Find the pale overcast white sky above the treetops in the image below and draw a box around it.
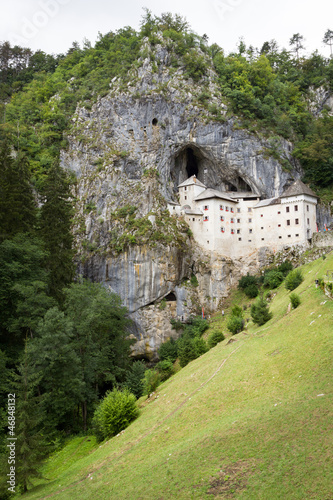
[0,0,333,56]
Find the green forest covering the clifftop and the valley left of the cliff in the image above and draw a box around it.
[0,11,333,489]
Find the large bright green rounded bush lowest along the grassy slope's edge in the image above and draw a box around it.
[93,389,139,441]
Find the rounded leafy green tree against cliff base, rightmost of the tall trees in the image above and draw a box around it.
[64,280,133,430]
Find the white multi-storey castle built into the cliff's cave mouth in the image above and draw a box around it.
[168,175,317,258]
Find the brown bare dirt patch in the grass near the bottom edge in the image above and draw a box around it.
[207,460,256,498]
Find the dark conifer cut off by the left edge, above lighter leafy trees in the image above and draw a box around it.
[0,140,36,240]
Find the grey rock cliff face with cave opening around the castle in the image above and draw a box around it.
[62,41,300,359]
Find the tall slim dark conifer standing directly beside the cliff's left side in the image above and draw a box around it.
[40,163,74,301]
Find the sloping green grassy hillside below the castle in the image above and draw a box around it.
[23,254,333,500]
